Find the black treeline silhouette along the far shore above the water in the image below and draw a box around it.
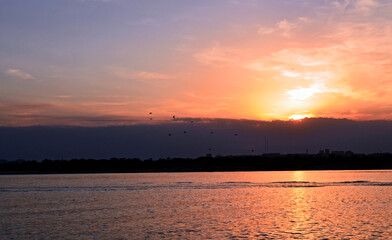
[0,153,392,174]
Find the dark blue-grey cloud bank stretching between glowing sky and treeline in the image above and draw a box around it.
[0,118,392,160]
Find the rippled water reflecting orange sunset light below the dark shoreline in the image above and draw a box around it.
[0,171,392,239]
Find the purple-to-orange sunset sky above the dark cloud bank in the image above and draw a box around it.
[0,0,392,126]
